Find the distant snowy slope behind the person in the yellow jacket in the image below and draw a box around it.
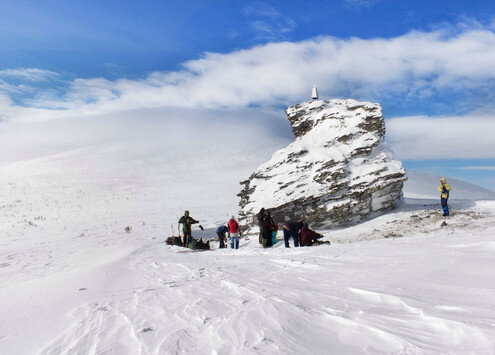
[403,170,495,200]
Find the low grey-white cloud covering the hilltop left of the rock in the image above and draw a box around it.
[0,108,290,167]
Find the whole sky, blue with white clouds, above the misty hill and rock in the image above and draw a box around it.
[0,0,495,189]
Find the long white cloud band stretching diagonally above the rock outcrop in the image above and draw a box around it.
[3,25,495,119]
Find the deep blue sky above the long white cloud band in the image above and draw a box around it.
[0,0,495,78]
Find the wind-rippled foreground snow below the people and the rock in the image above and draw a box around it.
[37,227,495,354]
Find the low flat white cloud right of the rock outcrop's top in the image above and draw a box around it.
[386,114,495,160]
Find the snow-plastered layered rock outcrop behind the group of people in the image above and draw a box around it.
[238,100,406,228]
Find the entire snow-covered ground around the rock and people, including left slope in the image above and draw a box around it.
[0,143,495,354]
